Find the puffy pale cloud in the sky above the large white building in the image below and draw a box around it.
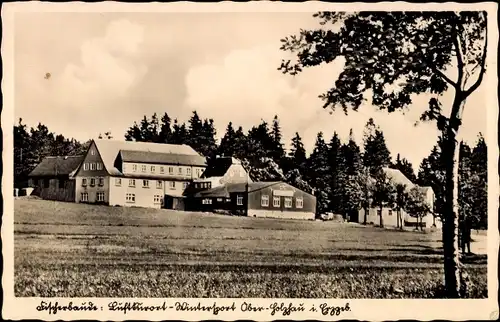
[58,20,147,108]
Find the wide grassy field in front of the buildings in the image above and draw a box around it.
[14,199,487,298]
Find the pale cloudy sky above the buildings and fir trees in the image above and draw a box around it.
[14,12,486,170]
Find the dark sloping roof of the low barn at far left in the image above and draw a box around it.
[29,155,84,177]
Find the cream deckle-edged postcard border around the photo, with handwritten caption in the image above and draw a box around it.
[2,1,499,321]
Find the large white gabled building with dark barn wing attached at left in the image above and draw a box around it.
[31,140,206,209]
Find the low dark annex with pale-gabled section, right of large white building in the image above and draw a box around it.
[185,156,316,220]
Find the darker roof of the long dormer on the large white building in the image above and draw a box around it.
[120,150,206,167]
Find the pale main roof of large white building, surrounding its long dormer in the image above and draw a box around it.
[94,140,206,175]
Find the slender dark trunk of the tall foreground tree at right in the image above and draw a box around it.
[442,117,464,298]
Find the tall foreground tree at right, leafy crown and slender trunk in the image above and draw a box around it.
[279,11,487,298]
